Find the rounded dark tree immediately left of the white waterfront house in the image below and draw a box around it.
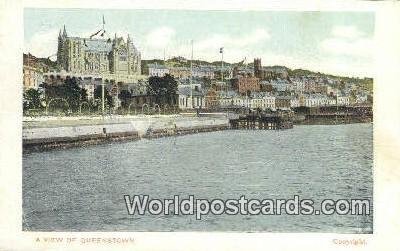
[148,74,178,105]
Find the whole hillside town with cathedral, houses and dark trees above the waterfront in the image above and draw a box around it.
[23,26,373,114]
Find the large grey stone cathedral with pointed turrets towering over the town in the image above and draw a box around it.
[57,26,141,77]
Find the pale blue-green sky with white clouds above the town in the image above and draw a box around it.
[24,8,375,77]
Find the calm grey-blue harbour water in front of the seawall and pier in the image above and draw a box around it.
[23,124,373,233]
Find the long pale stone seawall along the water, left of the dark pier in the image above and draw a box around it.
[22,117,229,152]
